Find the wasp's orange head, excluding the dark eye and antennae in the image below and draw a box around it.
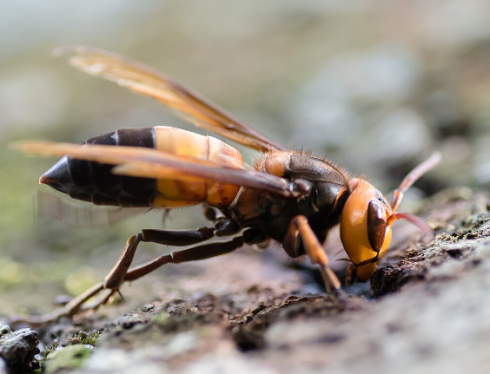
[340,179,391,280]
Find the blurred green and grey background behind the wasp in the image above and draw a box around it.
[0,0,490,314]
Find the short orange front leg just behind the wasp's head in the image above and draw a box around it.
[283,215,342,296]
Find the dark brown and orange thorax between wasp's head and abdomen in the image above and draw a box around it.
[227,152,349,242]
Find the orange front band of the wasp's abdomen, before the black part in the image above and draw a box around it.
[151,126,243,208]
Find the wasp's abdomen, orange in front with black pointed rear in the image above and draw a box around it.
[40,127,243,208]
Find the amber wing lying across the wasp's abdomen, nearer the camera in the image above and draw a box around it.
[13,142,299,197]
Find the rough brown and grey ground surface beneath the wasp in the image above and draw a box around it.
[0,189,490,373]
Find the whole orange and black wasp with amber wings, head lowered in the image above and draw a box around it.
[17,46,440,320]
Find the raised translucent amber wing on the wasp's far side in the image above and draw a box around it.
[55,46,284,152]
